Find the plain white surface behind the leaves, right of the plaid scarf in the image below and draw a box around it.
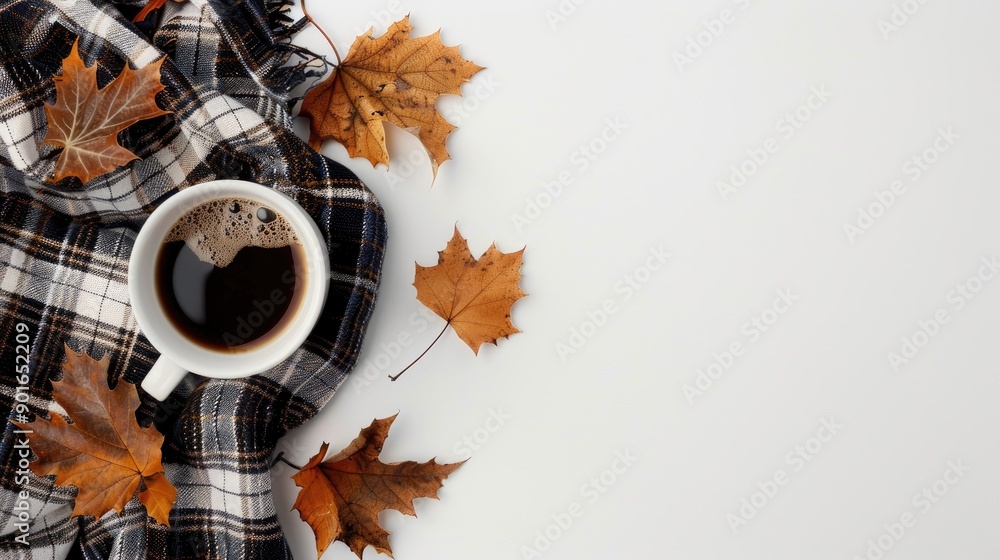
[274,0,1000,560]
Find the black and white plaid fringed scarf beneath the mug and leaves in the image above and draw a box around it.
[0,0,386,560]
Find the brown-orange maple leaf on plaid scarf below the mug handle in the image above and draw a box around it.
[17,346,177,526]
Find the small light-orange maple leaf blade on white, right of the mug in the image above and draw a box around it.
[413,227,527,354]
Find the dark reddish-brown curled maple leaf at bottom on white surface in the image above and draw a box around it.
[292,416,462,558]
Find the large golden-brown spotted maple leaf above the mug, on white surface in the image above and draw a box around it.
[301,16,482,176]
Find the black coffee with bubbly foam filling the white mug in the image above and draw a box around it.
[156,199,305,351]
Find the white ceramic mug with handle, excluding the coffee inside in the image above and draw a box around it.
[128,180,330,401]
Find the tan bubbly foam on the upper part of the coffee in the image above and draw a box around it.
[165,198,302,268]
